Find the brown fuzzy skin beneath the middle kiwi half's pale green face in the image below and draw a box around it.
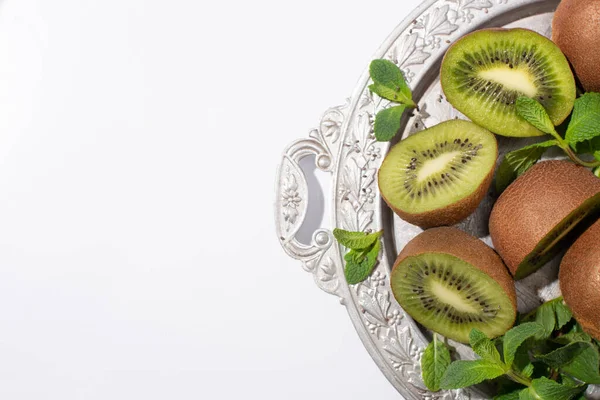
[378,142,498,229]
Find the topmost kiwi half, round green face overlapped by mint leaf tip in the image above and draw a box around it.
[441,29,575,137]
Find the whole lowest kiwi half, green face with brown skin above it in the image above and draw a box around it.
[390,227,517,343]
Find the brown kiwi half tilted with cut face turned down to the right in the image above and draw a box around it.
[489,160,600,279]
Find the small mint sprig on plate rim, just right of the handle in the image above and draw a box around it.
[333,228,383,285]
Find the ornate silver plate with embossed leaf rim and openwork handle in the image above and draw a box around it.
[275,0,595,400]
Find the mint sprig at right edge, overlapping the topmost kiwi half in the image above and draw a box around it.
[496,93,600,192]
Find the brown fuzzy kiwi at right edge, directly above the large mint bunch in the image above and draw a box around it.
[558,221,600,340]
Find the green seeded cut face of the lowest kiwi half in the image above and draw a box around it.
[392,253,515,343]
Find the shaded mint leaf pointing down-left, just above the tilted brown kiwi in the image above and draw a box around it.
[496,140,558,193]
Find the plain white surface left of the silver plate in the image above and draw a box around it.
[0,0,418,400]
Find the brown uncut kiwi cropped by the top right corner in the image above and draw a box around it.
[552,0,600,92]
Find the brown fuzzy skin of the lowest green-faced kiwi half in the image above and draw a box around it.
[392,227,517,318]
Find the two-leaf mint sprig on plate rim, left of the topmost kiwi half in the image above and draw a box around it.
[369,59,417,142]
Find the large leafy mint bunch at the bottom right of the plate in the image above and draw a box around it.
[421,298,600,400]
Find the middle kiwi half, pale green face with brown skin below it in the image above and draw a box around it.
[378,120,498,228]
